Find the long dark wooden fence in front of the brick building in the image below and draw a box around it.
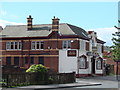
[1,73,75,87]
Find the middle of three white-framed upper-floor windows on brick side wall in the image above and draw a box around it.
[31,41,44,50]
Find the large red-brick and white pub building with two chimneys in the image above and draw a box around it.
[0,16,105,77]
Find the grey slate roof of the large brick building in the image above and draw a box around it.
[1,23,89,39]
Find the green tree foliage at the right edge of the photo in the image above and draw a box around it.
[111,27,120,60]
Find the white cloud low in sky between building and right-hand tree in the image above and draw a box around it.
[87,27,117,46]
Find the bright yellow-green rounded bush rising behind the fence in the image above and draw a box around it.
[26,64,48,73]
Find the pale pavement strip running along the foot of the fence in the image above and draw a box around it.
[12,81,101,90]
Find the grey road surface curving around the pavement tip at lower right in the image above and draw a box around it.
[48,76,120,90]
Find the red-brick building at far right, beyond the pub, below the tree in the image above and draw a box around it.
[103,46,120,74]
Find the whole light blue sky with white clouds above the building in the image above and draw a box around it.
[0,2,118,46]
